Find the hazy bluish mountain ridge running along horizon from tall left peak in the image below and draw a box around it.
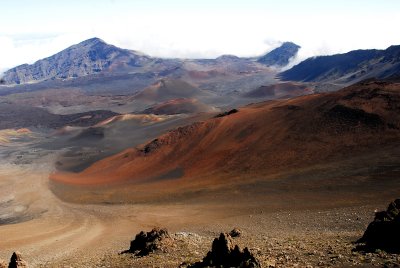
[2,37,300,85]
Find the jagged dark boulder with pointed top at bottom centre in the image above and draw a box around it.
[189,233,261,268]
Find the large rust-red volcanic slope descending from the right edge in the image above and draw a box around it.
[51,81,400,187]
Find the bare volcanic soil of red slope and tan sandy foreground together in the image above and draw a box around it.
[0,81,400,267]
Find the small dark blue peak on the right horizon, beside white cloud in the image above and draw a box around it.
[257,42,300,67]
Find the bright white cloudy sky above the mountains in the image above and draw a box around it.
[0,0,400,73]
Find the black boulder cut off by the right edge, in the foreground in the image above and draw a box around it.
[357,199,400,253]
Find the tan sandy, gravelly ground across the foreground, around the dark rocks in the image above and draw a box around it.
[0,146,400,267]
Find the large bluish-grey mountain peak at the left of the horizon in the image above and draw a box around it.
[3,37,151,84]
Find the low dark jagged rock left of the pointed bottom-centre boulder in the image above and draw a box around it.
[127,228,170,256]
